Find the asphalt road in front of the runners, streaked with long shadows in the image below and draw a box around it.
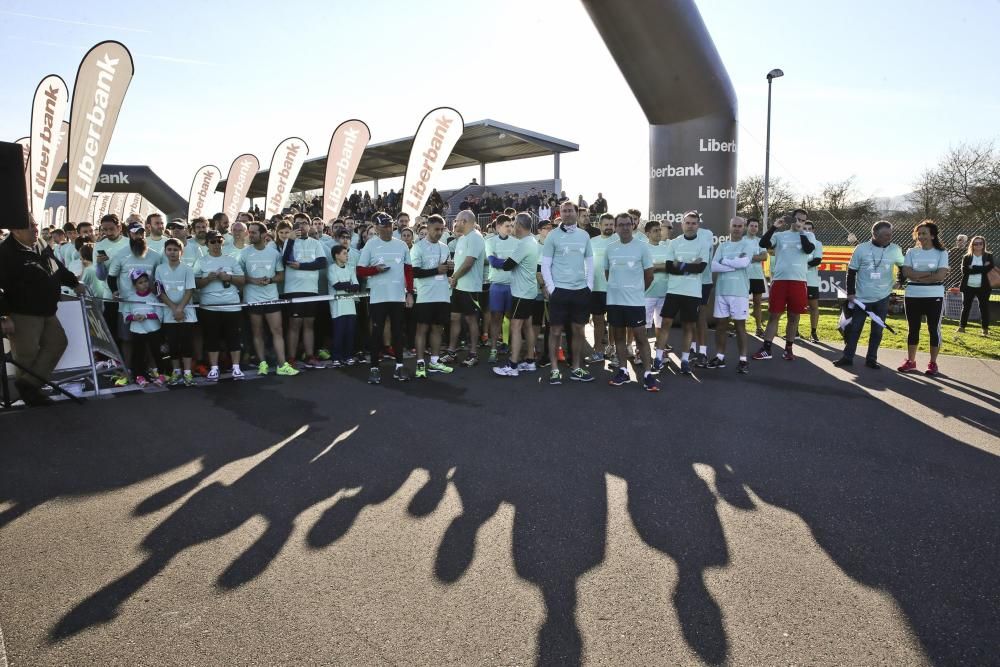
[0,346,1000,666]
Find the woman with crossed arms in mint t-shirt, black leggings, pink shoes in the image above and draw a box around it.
[897,220,948,375]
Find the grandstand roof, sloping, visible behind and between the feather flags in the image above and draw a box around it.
[217,118,580,198]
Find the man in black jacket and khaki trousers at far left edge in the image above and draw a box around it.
[0,221,87,405]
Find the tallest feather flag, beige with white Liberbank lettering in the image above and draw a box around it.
[68,41,135,221]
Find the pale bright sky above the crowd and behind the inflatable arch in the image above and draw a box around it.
[0,0,1000,210]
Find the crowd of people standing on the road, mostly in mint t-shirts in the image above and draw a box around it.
[0,195,994,402]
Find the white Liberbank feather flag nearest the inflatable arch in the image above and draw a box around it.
[401,107,465,219]
